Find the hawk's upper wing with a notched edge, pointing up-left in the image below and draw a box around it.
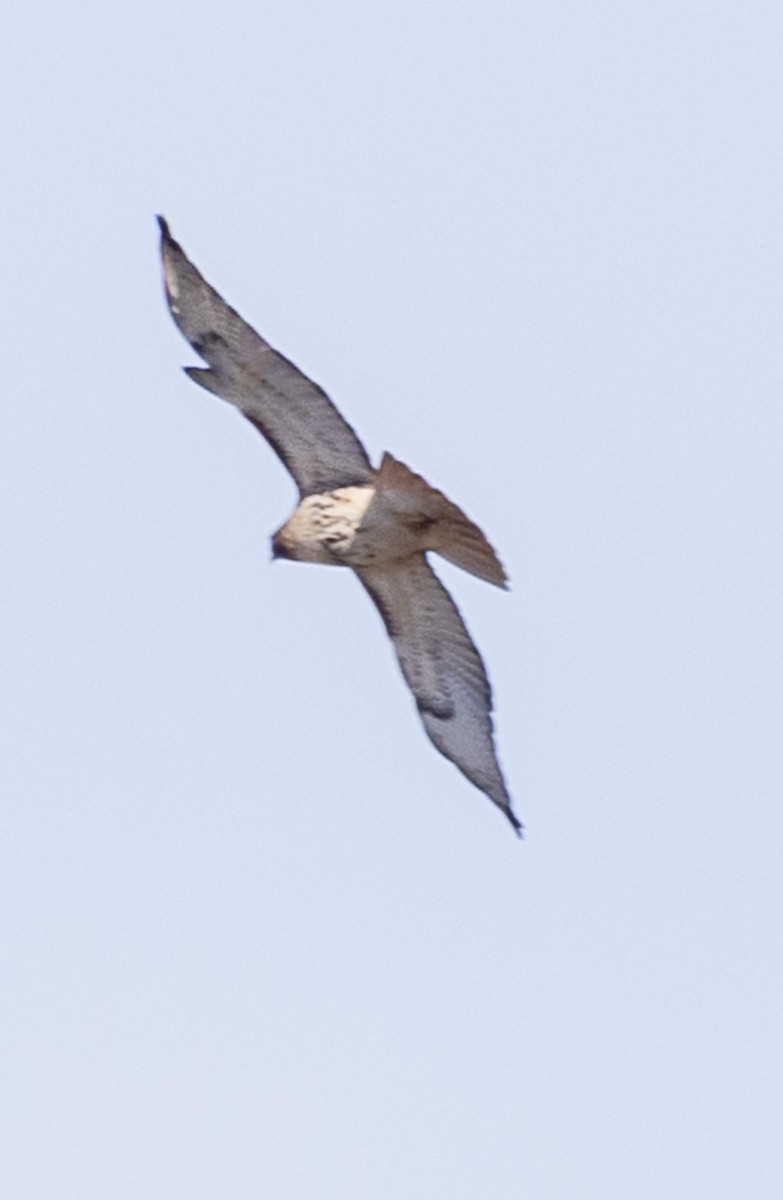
[159,217,372,496]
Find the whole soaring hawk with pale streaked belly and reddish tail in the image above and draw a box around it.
[159,217,522,835]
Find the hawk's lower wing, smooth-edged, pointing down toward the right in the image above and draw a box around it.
[355,554,522,833]
